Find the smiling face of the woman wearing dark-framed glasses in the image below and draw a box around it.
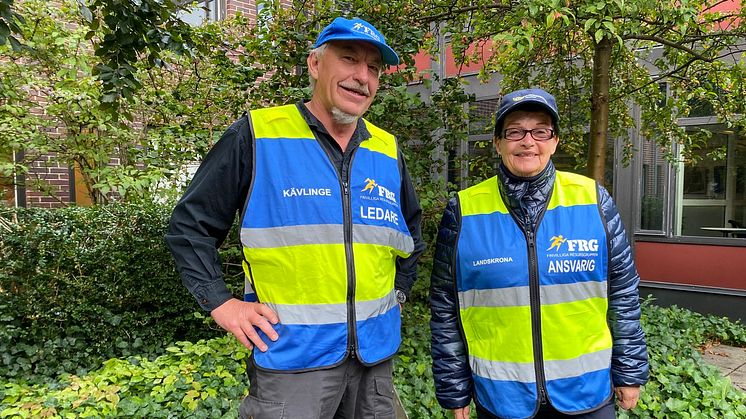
[494,110,559,177]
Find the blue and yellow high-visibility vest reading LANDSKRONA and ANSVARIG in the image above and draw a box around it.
[456,171,612,419]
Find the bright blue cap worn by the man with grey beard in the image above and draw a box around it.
[313,17,399,65]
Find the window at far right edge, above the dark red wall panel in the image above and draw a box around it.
[675,125,746,237]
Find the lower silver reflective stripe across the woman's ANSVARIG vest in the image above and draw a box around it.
[469,349,611,383]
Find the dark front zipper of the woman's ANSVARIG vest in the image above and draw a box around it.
[526,230,548,404]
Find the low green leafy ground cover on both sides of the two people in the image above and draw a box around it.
[0,301,746,419]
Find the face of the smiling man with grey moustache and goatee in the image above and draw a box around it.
[308,41,383,122]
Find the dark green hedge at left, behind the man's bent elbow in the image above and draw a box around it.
[0,204,238,381]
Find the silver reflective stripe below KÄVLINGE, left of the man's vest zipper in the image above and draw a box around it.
[241,224,344,248]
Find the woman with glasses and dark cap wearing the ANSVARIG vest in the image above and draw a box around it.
[430,89,648,419]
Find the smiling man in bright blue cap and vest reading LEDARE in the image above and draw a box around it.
[166,18,424,419]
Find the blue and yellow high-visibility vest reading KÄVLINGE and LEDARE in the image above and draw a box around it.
[240,105,414,371]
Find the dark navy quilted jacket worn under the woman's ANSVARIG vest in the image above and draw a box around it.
[430,162,648,409]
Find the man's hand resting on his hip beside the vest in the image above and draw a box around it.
[210,298,279,352]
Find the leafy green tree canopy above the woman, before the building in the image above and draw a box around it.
[424,0,746,176]
